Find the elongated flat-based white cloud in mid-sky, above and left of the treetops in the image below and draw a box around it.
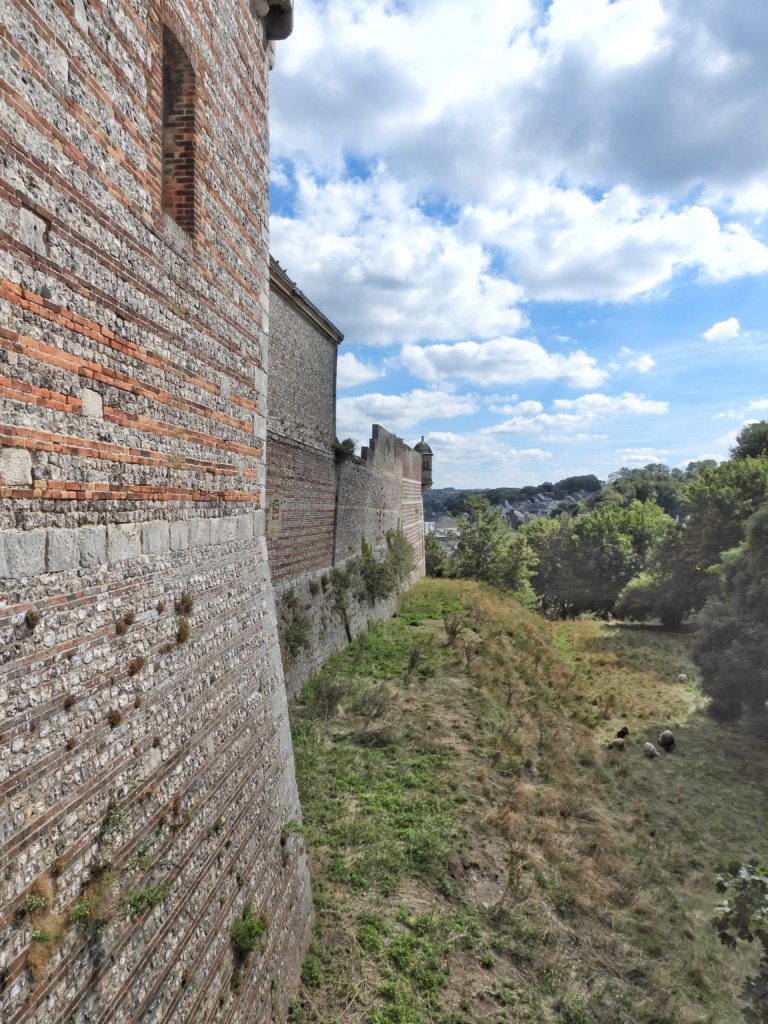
[401,337,608,387]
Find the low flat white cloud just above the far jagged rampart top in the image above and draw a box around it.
[336,388,478,439]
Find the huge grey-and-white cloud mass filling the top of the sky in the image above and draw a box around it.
[271,0,768,201]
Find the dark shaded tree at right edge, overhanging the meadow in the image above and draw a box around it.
[694,503,768,719]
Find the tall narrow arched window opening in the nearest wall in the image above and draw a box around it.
[163,27,195,236]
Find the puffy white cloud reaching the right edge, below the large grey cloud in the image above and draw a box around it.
[464,182,768,301]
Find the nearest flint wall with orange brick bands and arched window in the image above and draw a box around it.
[0,0,311,1024]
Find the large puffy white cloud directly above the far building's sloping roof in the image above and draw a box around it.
[271,166,525,345]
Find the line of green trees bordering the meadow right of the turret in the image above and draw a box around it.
[427,421,768,719]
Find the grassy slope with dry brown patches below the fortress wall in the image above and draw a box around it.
[291,581,768,1024]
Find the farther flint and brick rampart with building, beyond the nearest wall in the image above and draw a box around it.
[266,274,424,695]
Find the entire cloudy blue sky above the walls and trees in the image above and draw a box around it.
[271,0,768,486]
